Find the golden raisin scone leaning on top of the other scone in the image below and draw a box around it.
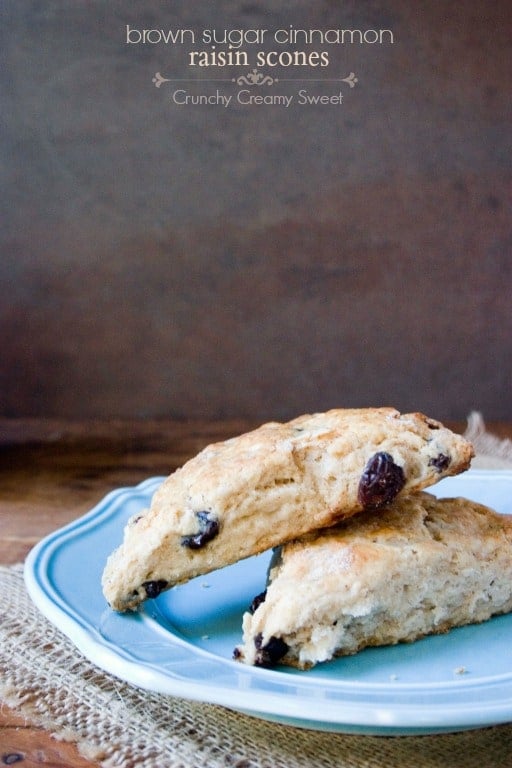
[103,408,472,611]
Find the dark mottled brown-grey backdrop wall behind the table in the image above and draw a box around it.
[0,0,512,419]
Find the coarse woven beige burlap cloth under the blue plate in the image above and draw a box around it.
[0,414,512,768]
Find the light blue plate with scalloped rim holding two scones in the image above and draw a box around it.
[25,470,512,736]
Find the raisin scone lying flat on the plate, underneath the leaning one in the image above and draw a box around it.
[235,492,512,669]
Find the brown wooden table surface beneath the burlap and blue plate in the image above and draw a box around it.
[0,420,512,768]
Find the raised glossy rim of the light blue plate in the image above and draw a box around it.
[24,468,512,735]
